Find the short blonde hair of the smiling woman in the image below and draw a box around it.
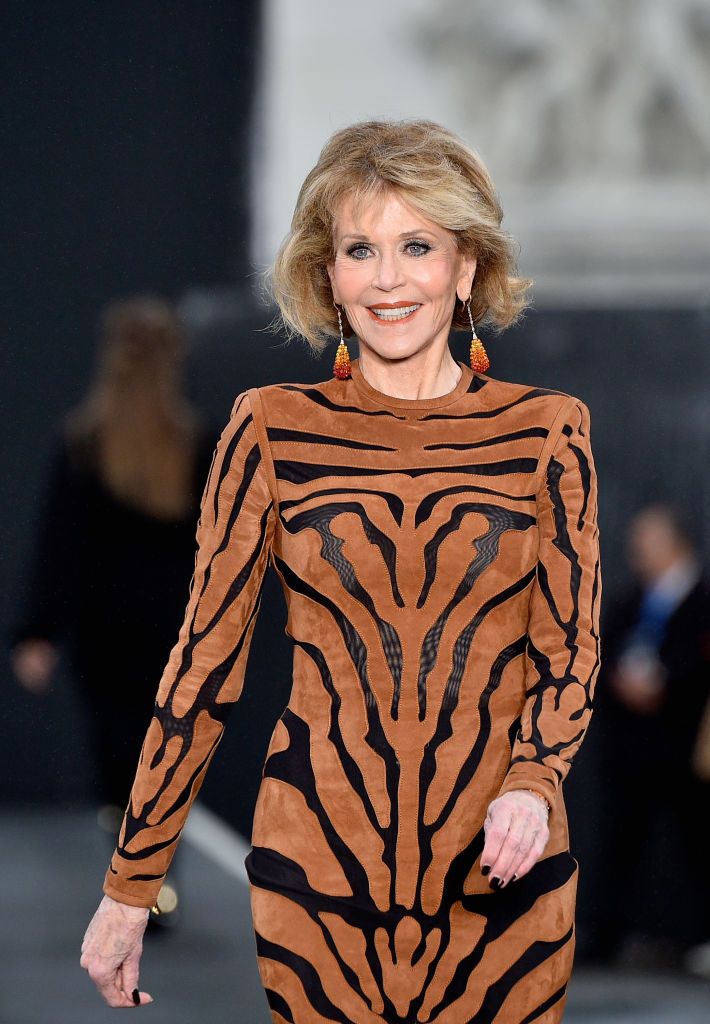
[262,120,533,354]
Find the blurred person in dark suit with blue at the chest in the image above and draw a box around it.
[592,502,710,970]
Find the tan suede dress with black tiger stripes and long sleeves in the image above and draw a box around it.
[103,359,601,1024]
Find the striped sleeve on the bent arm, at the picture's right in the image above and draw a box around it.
[498,397,601,804]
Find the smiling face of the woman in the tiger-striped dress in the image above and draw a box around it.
[327,193,476,359]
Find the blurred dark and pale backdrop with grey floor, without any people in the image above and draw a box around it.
[0,0,710,1024]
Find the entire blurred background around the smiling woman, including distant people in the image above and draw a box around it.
[0,0,710,1024]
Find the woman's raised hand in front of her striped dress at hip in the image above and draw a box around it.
[481,790,550,889]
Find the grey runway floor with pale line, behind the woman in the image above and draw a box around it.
[0,803,710,1024]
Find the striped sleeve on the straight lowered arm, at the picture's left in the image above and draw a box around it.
[103,391,276,907]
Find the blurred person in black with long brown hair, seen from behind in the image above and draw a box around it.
[10,295,215,926]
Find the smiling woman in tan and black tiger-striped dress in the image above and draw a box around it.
[81,121,601,1024]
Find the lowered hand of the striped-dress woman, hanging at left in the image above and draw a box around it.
[79,896,153,1007]
